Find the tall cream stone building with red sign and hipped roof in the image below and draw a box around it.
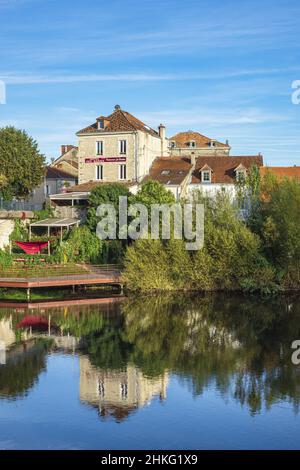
[77,106,168,184]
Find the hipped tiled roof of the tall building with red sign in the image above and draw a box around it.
[77,107,159,137]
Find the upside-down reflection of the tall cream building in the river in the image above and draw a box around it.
[79,356,168,422]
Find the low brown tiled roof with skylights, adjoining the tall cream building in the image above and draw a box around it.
[143,157,192,185]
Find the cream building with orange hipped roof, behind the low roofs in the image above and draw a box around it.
[169,131,230,157]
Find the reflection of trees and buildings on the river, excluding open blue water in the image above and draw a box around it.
[0,295,300,421]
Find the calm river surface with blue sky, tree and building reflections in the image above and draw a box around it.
[0,294,300,449]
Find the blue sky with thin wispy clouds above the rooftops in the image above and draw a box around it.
[0,0,300,166]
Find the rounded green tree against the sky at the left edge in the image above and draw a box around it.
[0,127,45,200]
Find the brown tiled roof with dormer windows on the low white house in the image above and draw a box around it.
[191,155,263,184]
